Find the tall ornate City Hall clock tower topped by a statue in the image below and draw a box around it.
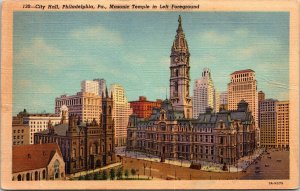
[170,15,192,118]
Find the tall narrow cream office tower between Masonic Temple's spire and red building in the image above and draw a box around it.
[110,84,132,146]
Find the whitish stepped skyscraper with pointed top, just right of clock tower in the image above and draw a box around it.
[193,68,219,118]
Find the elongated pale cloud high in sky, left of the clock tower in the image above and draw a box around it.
[70,26,123,46]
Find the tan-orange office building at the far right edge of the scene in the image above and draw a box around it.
[276,101,289,148]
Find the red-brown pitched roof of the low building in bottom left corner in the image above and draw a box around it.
[12,143,62,173]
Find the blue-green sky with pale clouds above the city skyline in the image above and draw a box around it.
[13,12,289,115]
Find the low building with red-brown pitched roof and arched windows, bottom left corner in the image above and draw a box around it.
[12,143,65,181]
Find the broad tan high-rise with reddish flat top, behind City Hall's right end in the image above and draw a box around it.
[228,69,258,126]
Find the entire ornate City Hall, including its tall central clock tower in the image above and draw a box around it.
[127,16,258,164]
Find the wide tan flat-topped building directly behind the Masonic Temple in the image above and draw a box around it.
[55,92,102,123]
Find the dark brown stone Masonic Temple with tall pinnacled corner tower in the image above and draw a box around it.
[34,92,116,174]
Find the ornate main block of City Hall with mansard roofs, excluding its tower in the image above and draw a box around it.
[127,100,256,164]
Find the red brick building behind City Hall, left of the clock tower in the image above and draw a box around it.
[129,96,162,118]
